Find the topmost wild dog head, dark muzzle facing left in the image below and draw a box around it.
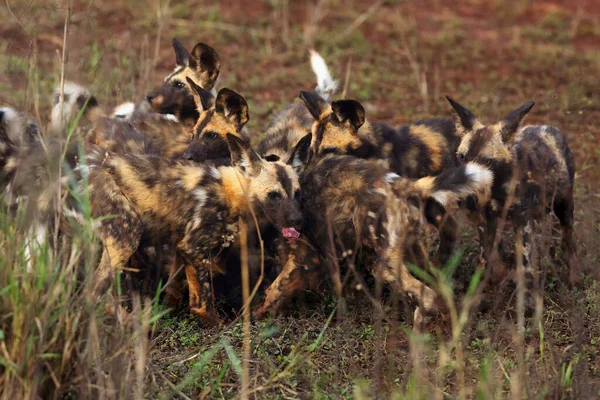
[146,39,221,119]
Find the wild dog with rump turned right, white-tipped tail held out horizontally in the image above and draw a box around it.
[255,134,493,323]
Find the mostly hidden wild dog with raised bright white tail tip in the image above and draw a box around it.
[258,50,337,161]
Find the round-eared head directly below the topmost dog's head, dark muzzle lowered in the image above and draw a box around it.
[183,82,250,162]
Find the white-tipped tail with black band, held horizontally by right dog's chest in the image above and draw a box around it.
[413,162,494,207]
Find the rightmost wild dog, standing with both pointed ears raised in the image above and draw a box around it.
[447,97,579,306]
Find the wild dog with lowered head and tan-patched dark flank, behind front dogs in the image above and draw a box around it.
[300,92,460,263]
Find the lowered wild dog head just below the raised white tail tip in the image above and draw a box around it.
[300,91,368,157]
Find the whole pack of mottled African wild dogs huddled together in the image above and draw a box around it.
[0,39,579,329]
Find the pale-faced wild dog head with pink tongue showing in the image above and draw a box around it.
[226,133,310,241]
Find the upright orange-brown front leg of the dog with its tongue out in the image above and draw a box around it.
[185,264,220,326]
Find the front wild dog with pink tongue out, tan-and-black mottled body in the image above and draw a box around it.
[89,108,302,323]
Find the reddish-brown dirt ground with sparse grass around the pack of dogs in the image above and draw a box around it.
[0,0,600,399]
